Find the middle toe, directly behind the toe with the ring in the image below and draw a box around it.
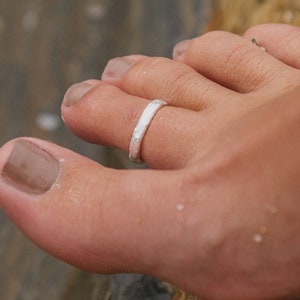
[102,55,234,111]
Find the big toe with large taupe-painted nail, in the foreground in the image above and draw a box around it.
[0,138,189,273]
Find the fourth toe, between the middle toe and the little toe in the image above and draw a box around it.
[174,31,299,93]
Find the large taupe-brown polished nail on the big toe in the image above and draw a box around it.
[1,140,60,195]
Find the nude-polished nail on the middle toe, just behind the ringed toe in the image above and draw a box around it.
[102,57,134,80]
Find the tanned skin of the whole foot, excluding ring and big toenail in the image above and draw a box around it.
[0,24,300,300]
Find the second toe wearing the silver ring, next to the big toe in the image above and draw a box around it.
[62,81,205,169]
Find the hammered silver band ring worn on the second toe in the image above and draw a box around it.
[129,99,168,164]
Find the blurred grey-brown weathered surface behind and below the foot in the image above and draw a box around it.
[0,0,210,300]
